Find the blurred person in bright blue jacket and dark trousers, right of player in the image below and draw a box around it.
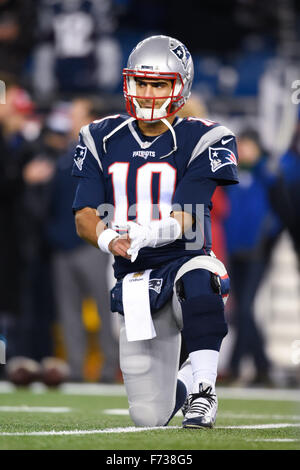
[225,130,280,385]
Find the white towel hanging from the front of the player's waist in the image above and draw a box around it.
[122,269,156,341]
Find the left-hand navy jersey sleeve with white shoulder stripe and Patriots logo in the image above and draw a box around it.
[72,126,105,212]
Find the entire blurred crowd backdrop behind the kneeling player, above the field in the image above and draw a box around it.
[0,0,300,386]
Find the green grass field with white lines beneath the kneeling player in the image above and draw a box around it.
[0,382,300,450]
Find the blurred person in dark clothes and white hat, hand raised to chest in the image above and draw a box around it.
[16,103,69,362]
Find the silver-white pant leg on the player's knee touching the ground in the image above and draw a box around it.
[120,302,181,426]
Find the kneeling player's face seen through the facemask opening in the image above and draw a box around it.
[136,78,173,108]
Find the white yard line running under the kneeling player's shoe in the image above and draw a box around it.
[0,423,300,436]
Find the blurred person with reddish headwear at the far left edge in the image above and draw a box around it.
[0,77,33,364]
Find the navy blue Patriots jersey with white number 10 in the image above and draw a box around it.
[73,115,238,278]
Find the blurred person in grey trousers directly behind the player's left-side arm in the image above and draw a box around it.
[47,98,118,383]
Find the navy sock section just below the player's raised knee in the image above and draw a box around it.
[181,294,228,353]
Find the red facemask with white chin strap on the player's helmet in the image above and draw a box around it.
[123,69,185,122]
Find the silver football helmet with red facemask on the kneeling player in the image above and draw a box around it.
[123,36,194,121]
